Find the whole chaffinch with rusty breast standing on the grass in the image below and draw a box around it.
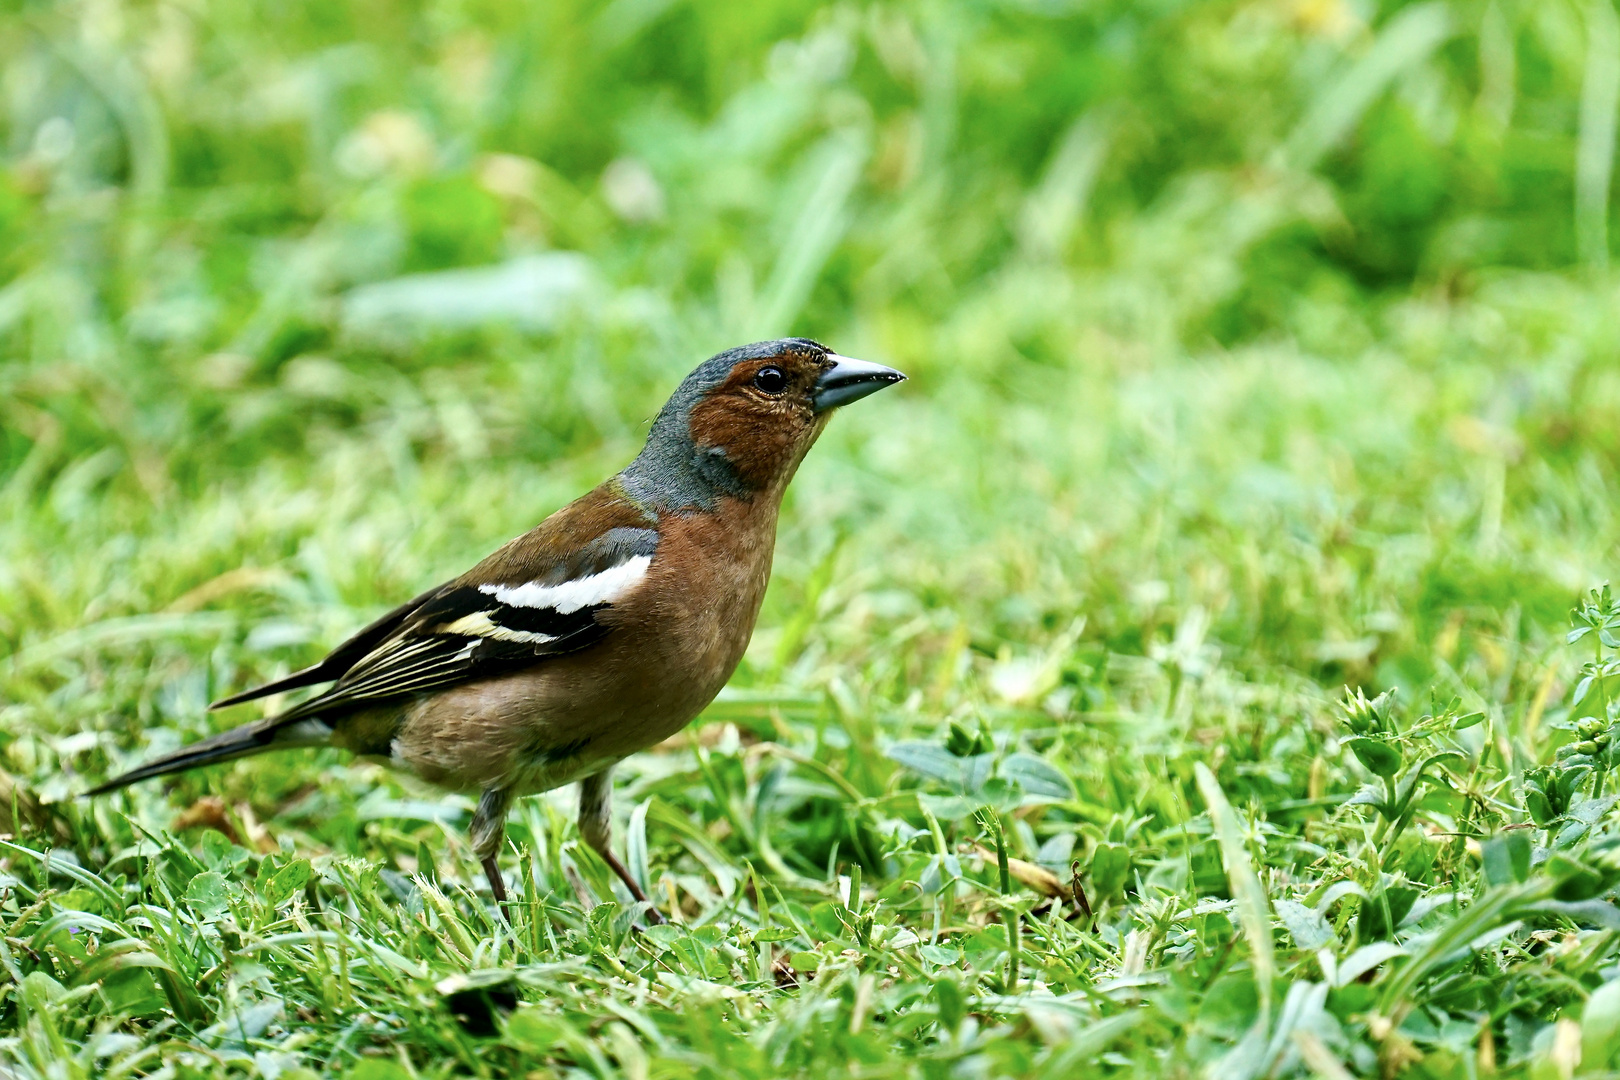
[84,338,906,921]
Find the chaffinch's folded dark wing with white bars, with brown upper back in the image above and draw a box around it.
[222,489,658,727]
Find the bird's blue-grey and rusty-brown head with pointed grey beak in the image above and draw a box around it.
[620,337,906,510]
